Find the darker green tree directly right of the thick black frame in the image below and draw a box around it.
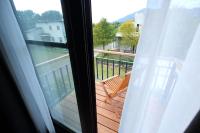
[93,18,115,49]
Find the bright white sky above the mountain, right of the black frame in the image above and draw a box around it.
[91,0,146,23]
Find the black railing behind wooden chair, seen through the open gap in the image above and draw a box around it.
[95,57,133,80]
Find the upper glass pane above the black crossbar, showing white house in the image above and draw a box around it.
[14,0,67,43]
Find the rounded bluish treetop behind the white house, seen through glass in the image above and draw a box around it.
[40,10,62,22]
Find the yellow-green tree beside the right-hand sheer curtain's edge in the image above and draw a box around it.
[118,20,139,52]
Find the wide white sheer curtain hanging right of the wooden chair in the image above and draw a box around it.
[119,0,200,133]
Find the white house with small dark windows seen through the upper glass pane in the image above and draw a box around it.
[25,21,66,43]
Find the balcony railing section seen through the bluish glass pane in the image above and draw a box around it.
[39,65,74,107]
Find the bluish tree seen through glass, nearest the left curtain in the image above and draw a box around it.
[17,10,40,31]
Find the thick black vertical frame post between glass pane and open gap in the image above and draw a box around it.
[61,0,97,133]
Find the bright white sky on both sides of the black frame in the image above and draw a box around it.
[14,0,147,23]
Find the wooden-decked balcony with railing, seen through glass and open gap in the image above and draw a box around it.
[29,42,134,133]
